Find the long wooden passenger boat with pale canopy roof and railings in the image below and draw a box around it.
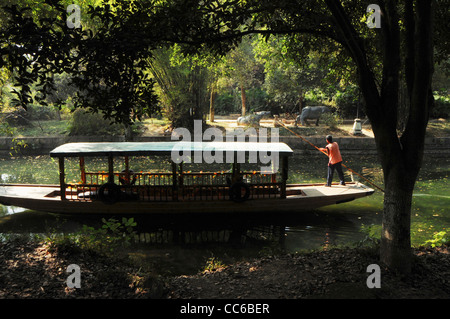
[0,141,374,214]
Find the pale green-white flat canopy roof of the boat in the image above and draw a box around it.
[50,141,293,157]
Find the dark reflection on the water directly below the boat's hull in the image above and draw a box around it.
[0,209,379,252]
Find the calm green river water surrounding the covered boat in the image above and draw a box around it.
[0,154,450,258]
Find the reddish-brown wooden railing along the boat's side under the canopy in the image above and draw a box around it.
[66,171,282,201]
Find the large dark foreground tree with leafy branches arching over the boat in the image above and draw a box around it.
[0,0,449,273]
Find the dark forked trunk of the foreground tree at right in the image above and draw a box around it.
[325,0,434,274]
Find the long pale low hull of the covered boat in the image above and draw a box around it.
[0,183,374,214]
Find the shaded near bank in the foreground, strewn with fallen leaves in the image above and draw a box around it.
[0,241,450,299]
